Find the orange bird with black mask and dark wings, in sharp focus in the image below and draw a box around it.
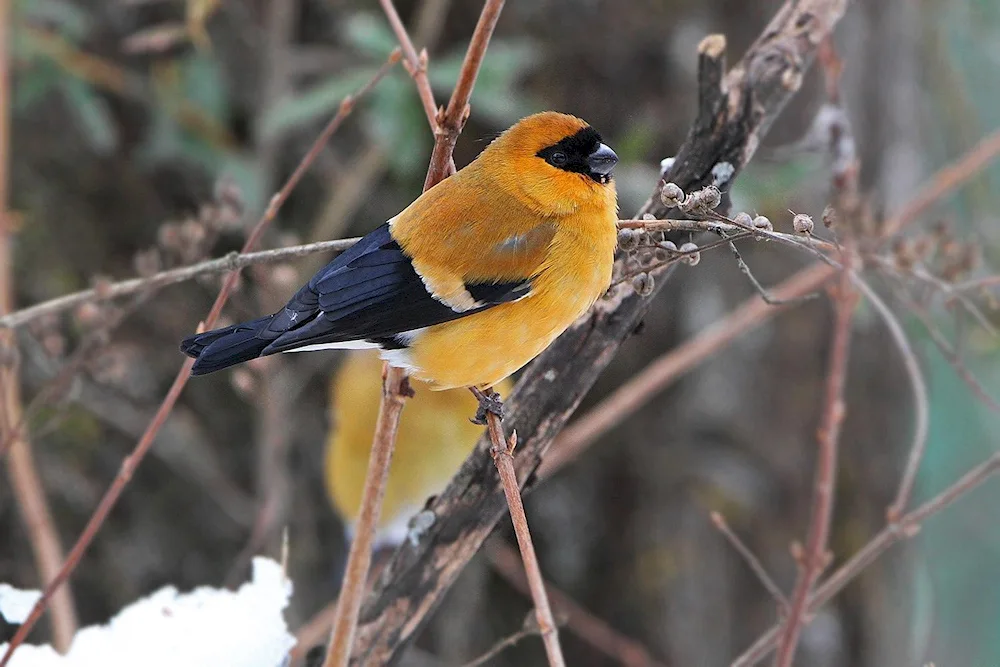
[181,112,618,389]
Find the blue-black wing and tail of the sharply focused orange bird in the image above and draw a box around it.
[181,223,531,375]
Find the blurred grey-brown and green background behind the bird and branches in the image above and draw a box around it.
[0,0,1000,667]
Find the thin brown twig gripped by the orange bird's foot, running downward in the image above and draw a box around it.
[486,412,566,667]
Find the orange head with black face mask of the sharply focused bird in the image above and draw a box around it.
[482,111,618,214]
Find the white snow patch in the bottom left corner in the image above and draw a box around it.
[0,558,295,667]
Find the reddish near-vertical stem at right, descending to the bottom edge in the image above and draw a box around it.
[775,257,858,667]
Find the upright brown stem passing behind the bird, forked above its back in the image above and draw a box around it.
[324,5,503,667]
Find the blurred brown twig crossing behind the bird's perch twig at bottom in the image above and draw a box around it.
[486,541,665,667]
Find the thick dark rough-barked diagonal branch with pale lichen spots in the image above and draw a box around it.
[354,0,847,665]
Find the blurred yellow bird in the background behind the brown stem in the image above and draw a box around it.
[324,350,510,548]
